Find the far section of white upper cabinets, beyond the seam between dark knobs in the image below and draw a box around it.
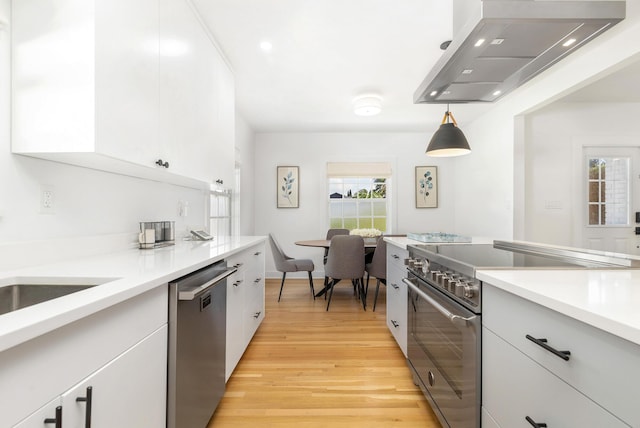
[160,0,234,187]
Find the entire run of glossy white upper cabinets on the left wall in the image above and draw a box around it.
[12,0,234,188]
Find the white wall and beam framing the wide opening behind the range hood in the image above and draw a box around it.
[454,0,640,239]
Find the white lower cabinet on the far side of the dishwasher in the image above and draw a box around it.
[225,243,265,380]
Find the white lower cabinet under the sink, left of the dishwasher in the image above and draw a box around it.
[0,286,168,428]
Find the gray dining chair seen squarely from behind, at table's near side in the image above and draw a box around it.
[324,235,367,311]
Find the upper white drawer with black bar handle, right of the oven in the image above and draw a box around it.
[482,284,640,426]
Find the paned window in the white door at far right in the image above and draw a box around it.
[587,157,630,226]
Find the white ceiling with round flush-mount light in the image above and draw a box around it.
[192,0,640,133]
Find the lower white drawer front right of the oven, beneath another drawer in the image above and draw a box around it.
[482,328,627,428]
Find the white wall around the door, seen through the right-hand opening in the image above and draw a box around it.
[524,103,640,245]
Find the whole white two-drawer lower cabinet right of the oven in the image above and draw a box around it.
[482,283,640,428]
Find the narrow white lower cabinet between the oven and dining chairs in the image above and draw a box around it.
[387,243,409,357]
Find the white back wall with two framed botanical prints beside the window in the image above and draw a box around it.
[254,133,456,276]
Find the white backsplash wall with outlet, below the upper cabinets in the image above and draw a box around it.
[0,0,205,270]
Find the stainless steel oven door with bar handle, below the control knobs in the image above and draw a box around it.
[403,273,482,428]
